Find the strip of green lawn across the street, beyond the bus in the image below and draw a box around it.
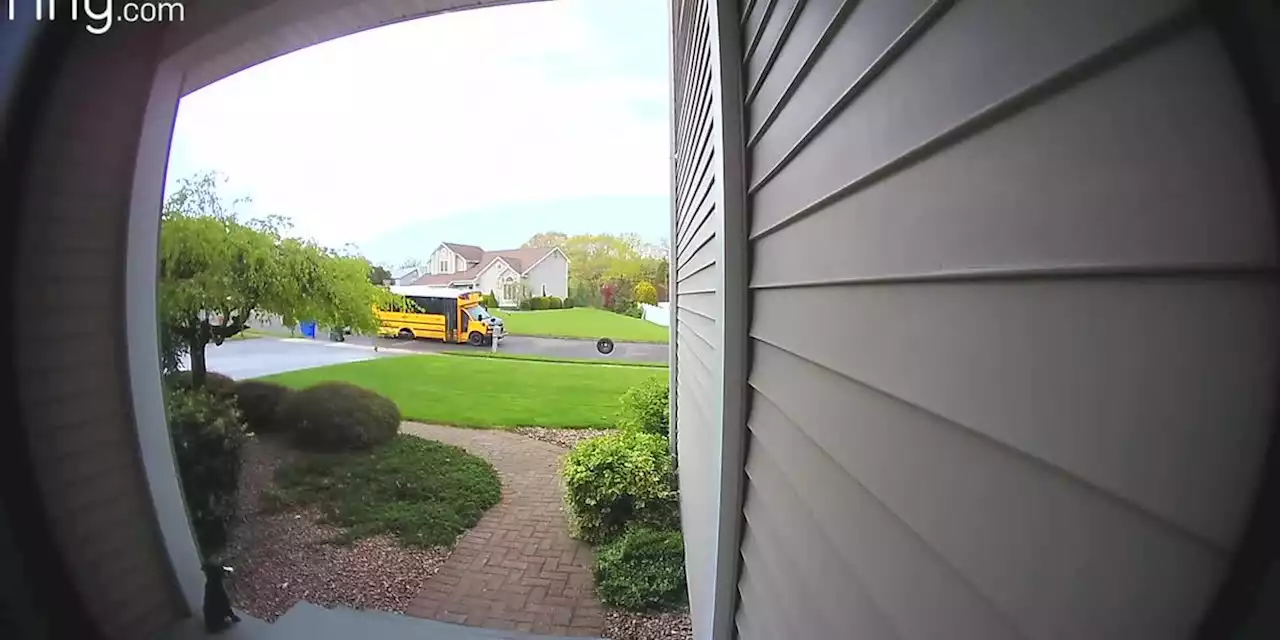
[494,308,669,343]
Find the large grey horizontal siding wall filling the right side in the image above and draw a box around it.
[736,0,1280,640]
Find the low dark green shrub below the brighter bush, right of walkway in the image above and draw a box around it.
[595,527,689,611]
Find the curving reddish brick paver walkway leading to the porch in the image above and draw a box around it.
[401,422,604,637]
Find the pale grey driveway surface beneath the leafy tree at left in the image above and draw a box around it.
[192,338,396,380]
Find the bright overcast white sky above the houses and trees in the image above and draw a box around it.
[169,0,669,262]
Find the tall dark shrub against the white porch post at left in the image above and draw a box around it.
[165,388,244,558]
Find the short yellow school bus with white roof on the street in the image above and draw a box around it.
[378,285,507,347]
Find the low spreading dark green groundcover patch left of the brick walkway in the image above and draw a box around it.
[268,435,502,547]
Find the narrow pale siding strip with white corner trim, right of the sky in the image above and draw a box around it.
[671,0,737,639]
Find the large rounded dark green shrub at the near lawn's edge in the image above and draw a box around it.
[278,381,401,452]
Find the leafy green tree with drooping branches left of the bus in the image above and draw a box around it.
[159,173,404,388]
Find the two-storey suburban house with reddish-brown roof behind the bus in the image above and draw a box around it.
[412,242,568,307]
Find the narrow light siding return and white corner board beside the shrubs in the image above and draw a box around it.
[669,0,749,640]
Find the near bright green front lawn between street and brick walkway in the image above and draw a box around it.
[265,356,667,428]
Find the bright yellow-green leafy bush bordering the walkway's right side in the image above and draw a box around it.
[562,431,680,543]
